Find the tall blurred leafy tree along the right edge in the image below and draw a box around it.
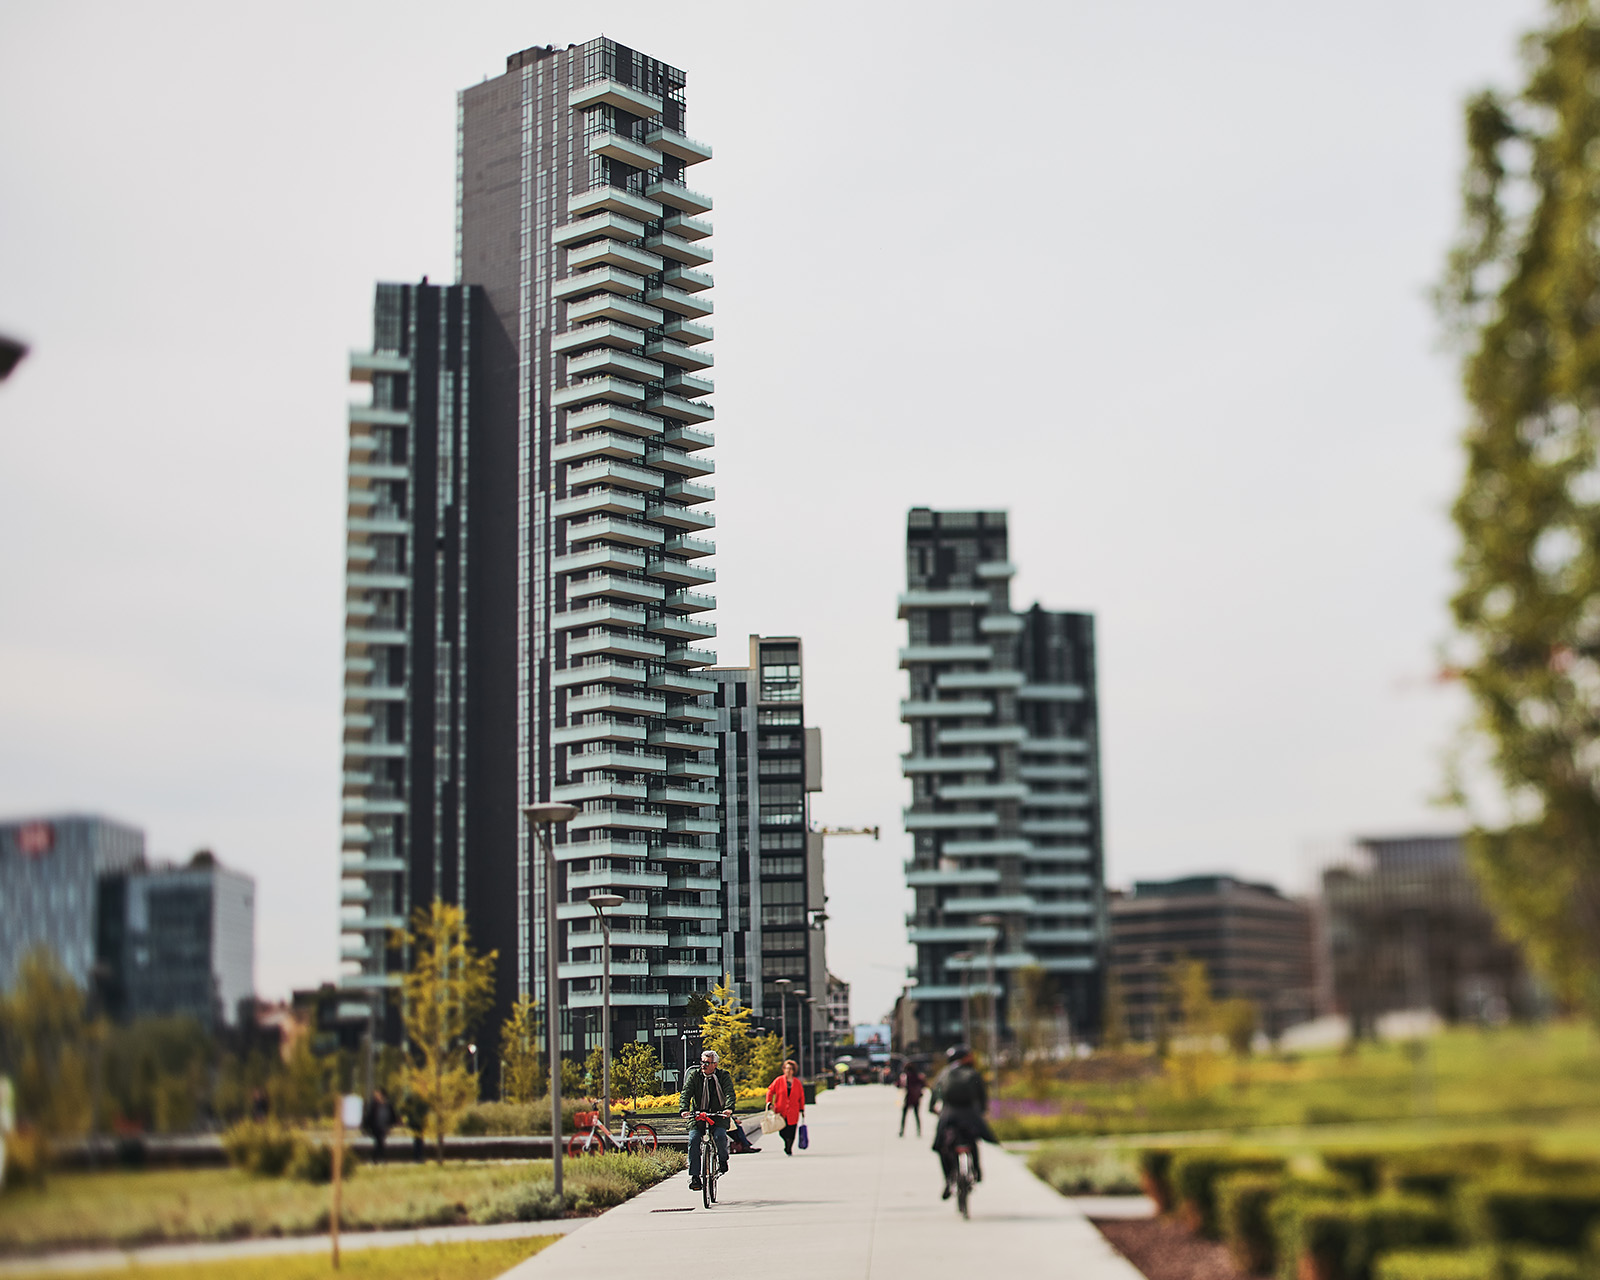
[1438,0,1600,1018]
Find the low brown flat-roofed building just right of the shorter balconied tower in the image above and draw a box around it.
[1110,875,1317,1040]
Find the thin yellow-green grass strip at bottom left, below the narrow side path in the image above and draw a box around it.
[3,1235,562,1280]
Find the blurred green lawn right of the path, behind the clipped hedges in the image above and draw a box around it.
[995,1024,1600,1141]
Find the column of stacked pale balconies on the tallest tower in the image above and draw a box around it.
[550,82,722,1008]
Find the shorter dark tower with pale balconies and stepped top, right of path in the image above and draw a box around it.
[899,507,1106,1046]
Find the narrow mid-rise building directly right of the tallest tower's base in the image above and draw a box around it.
[709,635,827,1068]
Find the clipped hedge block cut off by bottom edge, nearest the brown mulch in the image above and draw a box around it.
[1272,1195,1456,1280]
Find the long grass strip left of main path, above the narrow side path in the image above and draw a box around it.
[0,1150,685,1254]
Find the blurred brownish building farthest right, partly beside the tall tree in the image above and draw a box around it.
[1322,835,1541,1034]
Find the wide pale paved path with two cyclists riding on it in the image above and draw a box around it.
[502,1085,1142,1280]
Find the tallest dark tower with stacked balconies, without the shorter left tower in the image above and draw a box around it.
[342,38,722,1075]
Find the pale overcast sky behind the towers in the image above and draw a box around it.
[0,0,1539,1021]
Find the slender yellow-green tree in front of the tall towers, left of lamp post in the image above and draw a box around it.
[400,898,498,1163]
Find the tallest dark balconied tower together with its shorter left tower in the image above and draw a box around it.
[341,38,722,1078]
